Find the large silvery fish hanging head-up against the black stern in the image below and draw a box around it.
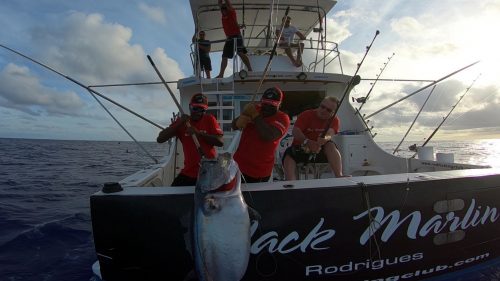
[193,153,250,281]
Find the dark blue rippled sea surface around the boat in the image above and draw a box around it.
[0,138,500,281]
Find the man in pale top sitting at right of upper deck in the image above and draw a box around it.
[276,16,306,67]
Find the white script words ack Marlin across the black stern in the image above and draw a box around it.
[250,199,500,254]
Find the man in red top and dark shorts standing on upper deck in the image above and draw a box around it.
[217,0,252,78]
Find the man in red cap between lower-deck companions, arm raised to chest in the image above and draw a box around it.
[233,87,290,183]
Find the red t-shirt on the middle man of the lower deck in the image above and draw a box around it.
[234,111,290,178]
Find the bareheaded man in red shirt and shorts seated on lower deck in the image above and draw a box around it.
[283,97,343,180]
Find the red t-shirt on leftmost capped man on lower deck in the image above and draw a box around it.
[175,114,223,175]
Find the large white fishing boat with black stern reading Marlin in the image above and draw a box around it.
[90,0,500,280]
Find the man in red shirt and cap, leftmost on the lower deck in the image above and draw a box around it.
[156,94,224,186]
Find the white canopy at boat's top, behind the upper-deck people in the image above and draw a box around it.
[190,0,337,52]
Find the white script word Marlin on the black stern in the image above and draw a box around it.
[353,199,499,245]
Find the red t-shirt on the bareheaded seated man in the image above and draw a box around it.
[292,109,340,145]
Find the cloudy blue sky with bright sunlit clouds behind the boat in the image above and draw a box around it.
[0,0,500,141]
